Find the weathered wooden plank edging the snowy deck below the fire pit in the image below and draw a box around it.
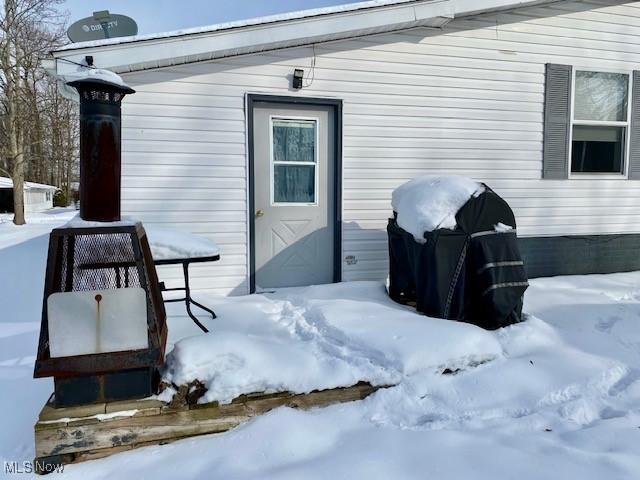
[35,382,386,463]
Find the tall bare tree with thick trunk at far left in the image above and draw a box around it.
[0,0,64,225]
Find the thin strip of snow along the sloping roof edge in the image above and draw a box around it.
[56,0,420,52]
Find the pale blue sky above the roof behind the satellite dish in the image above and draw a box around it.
[61,0,358,34]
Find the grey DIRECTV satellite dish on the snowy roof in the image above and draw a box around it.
[67,10,138,43]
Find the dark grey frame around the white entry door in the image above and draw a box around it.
[246,93,342,293]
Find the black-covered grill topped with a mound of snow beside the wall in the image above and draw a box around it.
[387,176,528,329]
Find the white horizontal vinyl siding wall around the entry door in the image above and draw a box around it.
[122,0,640,294]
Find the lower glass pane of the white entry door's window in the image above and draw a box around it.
[273,164,316,203]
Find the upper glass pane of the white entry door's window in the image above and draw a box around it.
[273,118,316,162]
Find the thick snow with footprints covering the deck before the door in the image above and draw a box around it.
[164,282,501,402]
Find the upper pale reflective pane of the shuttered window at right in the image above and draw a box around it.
[574,71,629,122]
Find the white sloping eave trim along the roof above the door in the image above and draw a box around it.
[51,0,550,76]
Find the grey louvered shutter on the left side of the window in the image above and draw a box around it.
[542,63,572,179]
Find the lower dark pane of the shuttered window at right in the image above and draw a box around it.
[571,125,625,173]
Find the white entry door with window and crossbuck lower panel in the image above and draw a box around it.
[252,103,336,291]
